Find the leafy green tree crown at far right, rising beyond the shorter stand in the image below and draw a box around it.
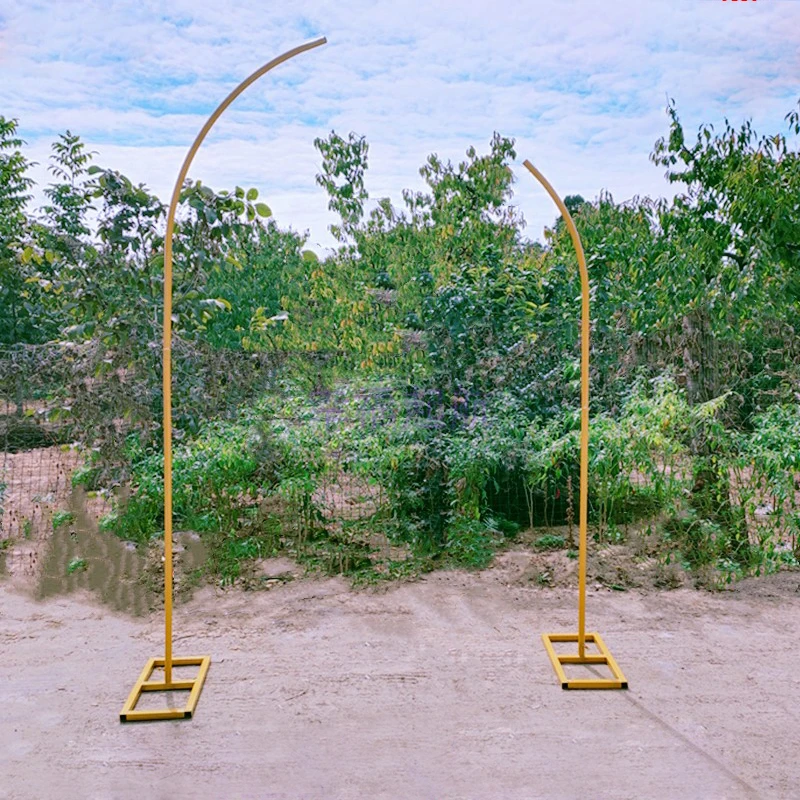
[651,103,800,402]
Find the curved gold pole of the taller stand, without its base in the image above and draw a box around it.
[163,36,327,685]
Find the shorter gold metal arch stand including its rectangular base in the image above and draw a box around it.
[524,160,628,689]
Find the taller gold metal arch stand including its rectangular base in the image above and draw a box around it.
[119,37,327,722]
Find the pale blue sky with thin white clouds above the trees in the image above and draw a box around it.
[0,0,800,250]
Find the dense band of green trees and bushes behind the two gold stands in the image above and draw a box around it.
[0,98,800,580]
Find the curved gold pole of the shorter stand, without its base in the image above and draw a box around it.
[523,159,589,658]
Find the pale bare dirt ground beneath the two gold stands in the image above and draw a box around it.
[0,551,800,800]
